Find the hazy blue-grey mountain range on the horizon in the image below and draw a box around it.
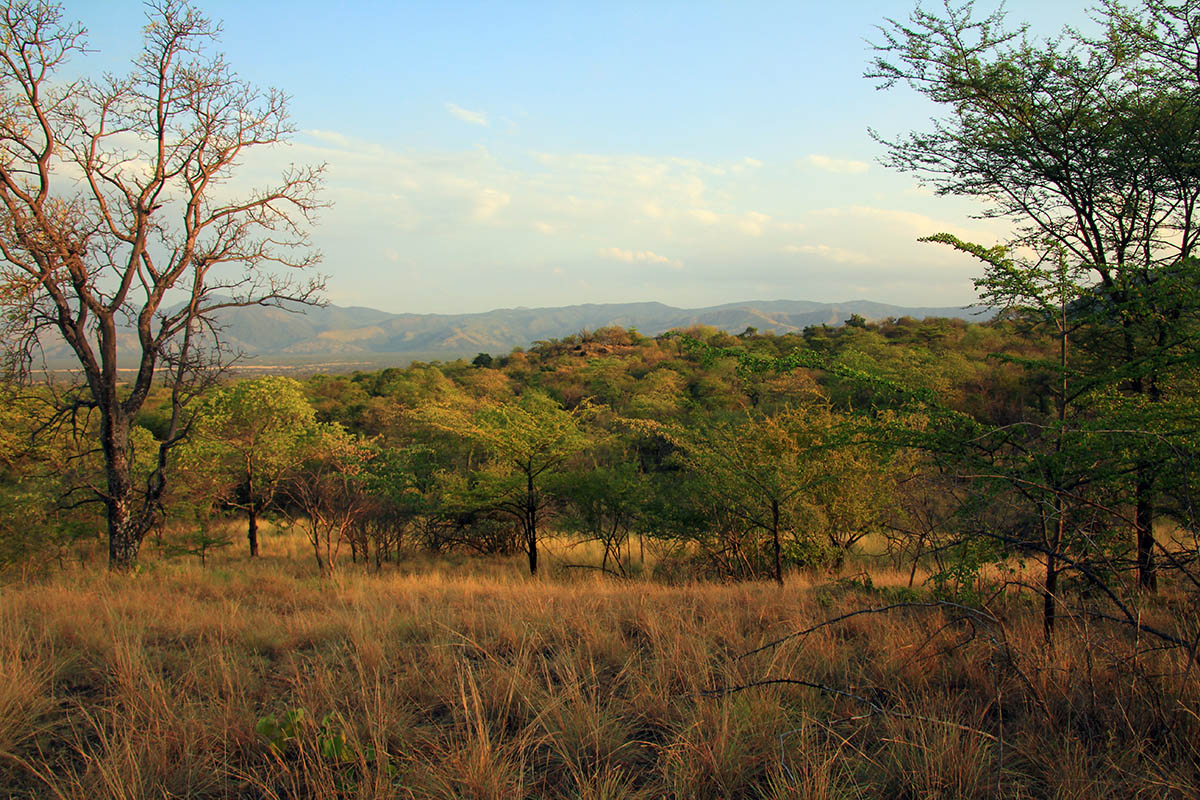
[37,300,989,367]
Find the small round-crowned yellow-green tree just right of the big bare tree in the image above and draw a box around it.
[180,377,317,557]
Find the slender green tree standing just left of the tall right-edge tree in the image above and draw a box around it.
[931,234,1124,640]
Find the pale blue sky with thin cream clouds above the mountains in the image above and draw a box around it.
[66,0,1088,313]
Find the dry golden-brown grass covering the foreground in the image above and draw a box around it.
[0,527,1200,799]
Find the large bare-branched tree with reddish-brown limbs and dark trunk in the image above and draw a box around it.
[0,0,322,569]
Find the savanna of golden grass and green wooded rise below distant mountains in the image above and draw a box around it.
[0,319,1200,800]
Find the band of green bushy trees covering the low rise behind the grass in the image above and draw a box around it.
[0,314,1196,632]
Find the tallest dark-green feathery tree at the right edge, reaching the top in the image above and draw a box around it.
[869,0,1200,589]
